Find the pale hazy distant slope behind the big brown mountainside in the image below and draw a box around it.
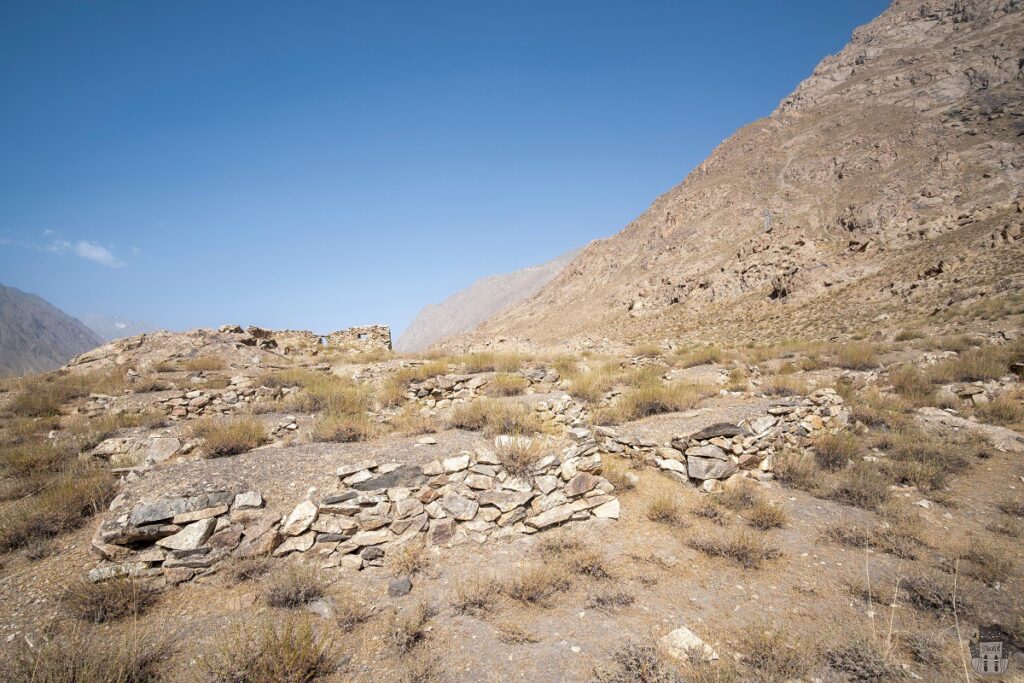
[394,249,580,351]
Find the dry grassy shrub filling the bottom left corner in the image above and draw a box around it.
[0,627,169,683]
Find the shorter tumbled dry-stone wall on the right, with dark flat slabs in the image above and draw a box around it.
[597,389,849,492]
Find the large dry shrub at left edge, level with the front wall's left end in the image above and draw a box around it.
[0,463,115,551]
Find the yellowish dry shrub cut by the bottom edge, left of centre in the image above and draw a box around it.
[199,615,336,683]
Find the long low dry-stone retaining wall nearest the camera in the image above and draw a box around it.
[90,436,620,583]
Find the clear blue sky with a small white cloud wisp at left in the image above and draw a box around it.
[0,0,887,333]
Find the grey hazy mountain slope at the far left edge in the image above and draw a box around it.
[0,285,103,376]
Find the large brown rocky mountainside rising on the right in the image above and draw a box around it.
[469,0,1024,344]
